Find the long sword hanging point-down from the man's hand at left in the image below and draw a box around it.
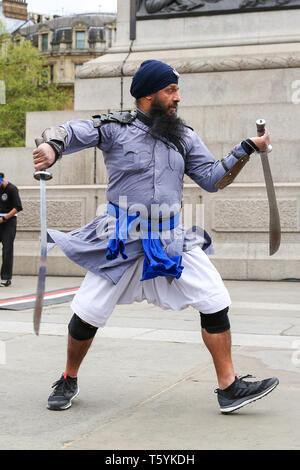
[33,138,52,335]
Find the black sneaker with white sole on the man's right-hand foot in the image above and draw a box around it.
[215,375,279,414]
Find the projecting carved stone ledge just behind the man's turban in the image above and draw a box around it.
[77,43,300,79]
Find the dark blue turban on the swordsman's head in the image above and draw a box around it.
[130,60,179,99]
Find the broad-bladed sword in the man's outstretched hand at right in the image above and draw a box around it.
[256,119,281,256]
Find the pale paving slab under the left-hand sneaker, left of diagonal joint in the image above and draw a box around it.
[0,335,209,449]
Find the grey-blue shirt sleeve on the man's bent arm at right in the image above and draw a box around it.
[185,132,250,192]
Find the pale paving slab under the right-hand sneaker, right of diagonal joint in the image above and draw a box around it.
[65,348,300,450]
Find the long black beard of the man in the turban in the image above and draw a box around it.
[149,102,184,139]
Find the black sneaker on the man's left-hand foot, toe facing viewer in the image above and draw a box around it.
[48,374,79,410]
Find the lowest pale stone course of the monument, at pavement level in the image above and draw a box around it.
[7,240,300,281]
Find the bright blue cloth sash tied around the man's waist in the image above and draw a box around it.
[106,203,183,281]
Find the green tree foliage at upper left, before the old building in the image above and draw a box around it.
[0,41,71,147]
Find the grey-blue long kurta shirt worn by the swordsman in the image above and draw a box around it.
[48,111,245,283]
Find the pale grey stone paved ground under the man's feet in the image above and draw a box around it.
[0,277,300,450]
